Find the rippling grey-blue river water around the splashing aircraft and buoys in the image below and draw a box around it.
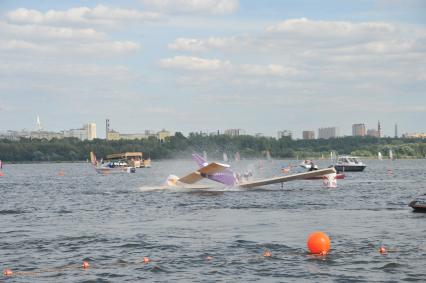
[0,160,426,282]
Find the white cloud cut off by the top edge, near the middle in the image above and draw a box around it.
[141,0,239,15]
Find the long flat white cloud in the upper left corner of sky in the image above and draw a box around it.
[7,5,160,27]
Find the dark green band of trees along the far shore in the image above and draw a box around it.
[0,135,426,162]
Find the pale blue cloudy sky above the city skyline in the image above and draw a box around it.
[0,0,426,138]
